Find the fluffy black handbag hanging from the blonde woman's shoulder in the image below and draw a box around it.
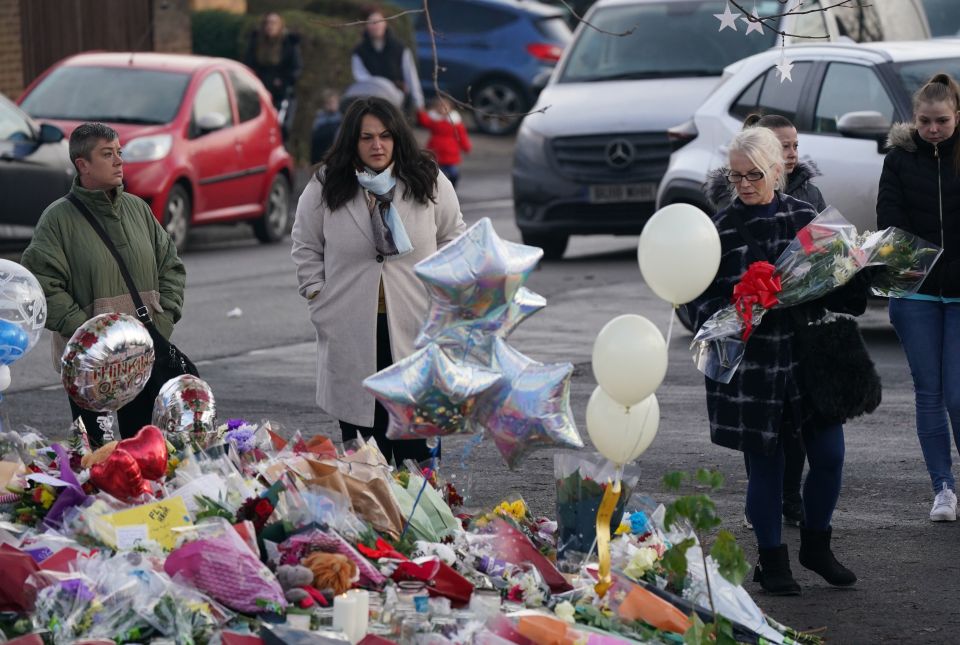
[727,210,883,425]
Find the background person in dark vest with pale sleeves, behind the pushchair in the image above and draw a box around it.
[350,7,424,113]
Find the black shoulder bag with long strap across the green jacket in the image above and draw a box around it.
[67,193,200,390]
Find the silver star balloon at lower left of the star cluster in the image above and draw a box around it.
[363,343,501,439]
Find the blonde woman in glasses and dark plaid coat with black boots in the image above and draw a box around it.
[687,128,865,595]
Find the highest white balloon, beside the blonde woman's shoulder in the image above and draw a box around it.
[637,204,720,305]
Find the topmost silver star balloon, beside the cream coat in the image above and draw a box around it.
[414,217,543,320]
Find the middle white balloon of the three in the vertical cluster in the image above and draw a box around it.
[593,314,667,406]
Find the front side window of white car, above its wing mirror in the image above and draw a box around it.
[813,63,894,132]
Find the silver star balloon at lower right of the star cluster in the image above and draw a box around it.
[474,338,583,469]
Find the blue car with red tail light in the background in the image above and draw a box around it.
[392,0,571,134]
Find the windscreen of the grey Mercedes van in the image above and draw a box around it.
[558,0,782,83]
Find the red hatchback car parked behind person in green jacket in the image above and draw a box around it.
[20,52,293,249]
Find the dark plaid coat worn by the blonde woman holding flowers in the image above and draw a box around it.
[686,192,817,454]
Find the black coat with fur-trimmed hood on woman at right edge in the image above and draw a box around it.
[877,123,960,298]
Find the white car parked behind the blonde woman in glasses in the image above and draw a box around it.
[657,39,960,231]
